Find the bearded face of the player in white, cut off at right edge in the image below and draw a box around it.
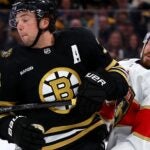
[142,40,150,67]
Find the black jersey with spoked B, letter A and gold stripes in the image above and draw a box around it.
[0,28,125,150]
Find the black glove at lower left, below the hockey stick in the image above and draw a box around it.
[8,116,45,150]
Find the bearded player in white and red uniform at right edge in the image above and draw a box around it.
[107,32,150,150]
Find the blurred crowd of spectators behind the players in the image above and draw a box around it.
[0,0,150,60]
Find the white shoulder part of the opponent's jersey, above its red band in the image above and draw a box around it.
[119,59,150,107]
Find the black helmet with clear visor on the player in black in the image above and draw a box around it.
[9,0,56,32]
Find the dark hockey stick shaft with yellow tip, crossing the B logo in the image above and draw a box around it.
[0,99,75,114]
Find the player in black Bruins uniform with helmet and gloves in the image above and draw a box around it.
[0,0,128,150]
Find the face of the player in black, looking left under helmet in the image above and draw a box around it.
[16,11,38,46]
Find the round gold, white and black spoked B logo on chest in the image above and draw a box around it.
[39,67,81,114]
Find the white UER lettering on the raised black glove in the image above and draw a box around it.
[85,73,106,86]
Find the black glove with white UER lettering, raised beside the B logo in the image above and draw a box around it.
[78,70,115,103]
